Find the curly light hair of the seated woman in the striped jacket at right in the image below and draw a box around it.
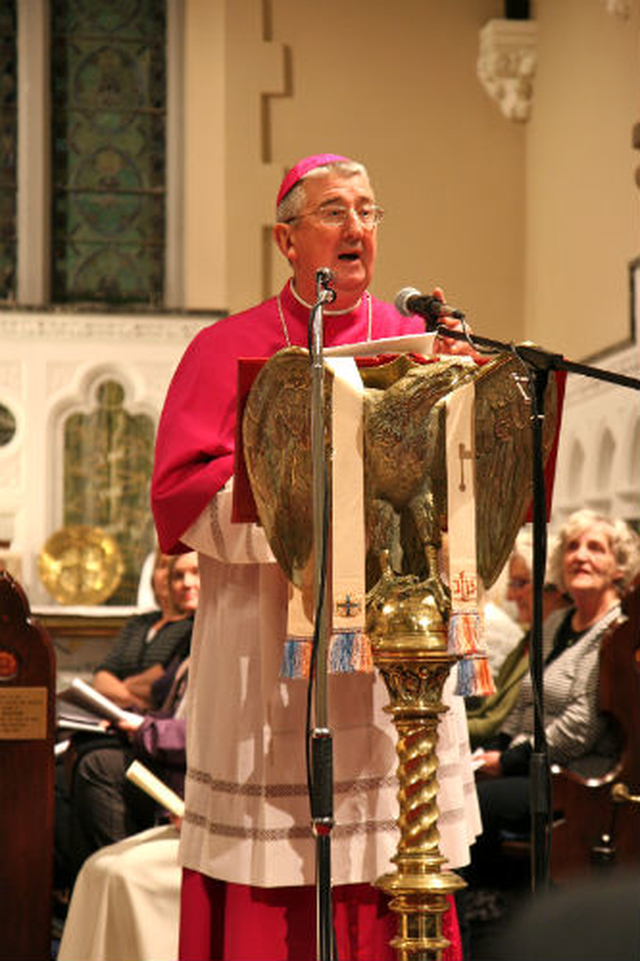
[549,509,640,597]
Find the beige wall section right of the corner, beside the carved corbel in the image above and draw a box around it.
[524,0,640,360]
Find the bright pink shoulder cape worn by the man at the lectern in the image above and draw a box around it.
[151,284,424,553]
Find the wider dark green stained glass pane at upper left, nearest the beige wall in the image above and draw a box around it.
[51,0,166,306]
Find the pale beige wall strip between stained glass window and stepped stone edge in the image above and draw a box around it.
[184,0,284,311]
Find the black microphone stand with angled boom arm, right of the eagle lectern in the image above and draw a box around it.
[427,317,640,892]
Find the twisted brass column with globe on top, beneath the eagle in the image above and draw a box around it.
[367,575,464,961]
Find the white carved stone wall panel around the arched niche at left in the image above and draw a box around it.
[0,311,211,605]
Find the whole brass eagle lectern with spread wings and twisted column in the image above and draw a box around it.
[243,348,556,961]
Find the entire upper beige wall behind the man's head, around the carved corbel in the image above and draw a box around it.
[184,0,640,359]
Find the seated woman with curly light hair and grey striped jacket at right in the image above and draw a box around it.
[469,510,639,882]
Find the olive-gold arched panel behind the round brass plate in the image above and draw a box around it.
[64,380,155,604]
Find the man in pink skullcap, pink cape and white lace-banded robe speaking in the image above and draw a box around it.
[152,154,479,961]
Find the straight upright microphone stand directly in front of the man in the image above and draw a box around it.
[307,268,336,961]
